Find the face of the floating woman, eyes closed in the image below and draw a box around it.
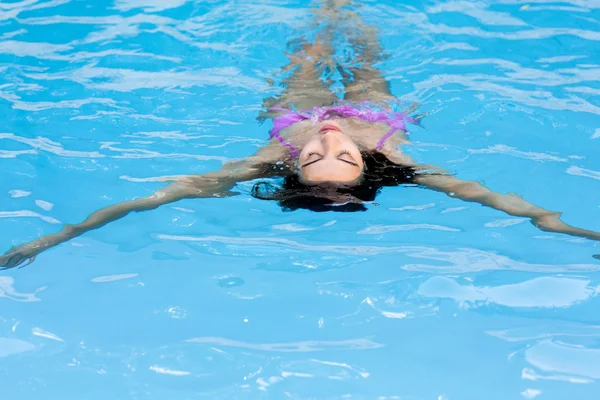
[299,120,364,183]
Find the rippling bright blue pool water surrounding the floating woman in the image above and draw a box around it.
[0,0,600,400]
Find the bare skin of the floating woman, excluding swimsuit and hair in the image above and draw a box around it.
[0,0,600,269]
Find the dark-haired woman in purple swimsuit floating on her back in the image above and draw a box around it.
[0,1,600,269]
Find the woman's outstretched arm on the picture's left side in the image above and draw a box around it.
[0,144,284,269]
